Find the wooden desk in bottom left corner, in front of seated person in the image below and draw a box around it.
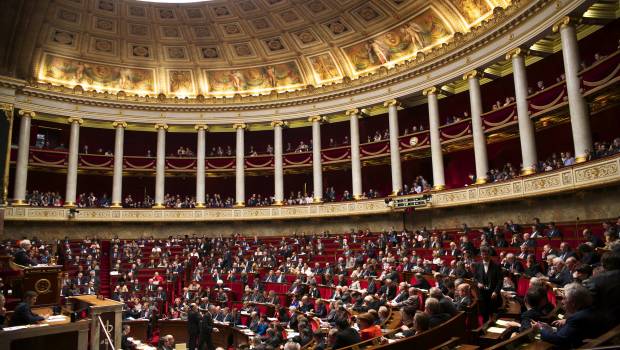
[0,320,90,350]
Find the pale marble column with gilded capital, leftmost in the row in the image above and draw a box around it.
[13,109,35,205]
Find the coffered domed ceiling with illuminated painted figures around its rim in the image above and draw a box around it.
[33,0,510,97]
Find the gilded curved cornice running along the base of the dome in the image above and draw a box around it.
[1,0,564,118]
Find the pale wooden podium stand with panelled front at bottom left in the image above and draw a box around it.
[68,295,123,350]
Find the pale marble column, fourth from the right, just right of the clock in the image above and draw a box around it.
[423,86,446,191]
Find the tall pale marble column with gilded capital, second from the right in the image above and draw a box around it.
[506,48,538,175]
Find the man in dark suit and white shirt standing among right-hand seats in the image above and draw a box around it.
[474,247,503,322]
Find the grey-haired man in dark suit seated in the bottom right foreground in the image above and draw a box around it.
[536,283,606,348]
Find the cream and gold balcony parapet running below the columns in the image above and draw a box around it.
[5,155,620,222]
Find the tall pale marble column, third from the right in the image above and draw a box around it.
[463,70,489,184]
